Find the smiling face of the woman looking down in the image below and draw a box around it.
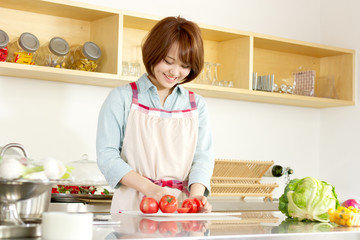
[151,44,191,90]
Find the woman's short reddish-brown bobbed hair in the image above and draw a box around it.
[142,17,204,83]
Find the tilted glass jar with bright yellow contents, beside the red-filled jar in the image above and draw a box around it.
[6,32,40,65]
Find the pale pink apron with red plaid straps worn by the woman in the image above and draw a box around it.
[111,82,199,213]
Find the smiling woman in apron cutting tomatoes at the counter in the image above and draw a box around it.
[96,17,214,213]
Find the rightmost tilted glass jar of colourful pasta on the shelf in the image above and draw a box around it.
[67,41,101,72]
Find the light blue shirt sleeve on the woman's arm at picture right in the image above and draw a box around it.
[189,95,215,196]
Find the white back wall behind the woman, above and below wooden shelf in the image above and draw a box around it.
[0,0,338,197]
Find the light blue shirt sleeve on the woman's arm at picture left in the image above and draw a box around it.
[96,87,132,188]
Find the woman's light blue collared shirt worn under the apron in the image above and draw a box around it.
[96,74,214,196]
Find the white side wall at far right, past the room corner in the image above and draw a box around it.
[320,0,360,200]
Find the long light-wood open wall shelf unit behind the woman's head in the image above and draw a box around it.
[0,0,355,108]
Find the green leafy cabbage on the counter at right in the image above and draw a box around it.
[279,177,340,222]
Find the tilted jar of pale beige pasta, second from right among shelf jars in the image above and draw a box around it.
[34,37,70,68]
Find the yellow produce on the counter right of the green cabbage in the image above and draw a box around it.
[328,206,360,227]
